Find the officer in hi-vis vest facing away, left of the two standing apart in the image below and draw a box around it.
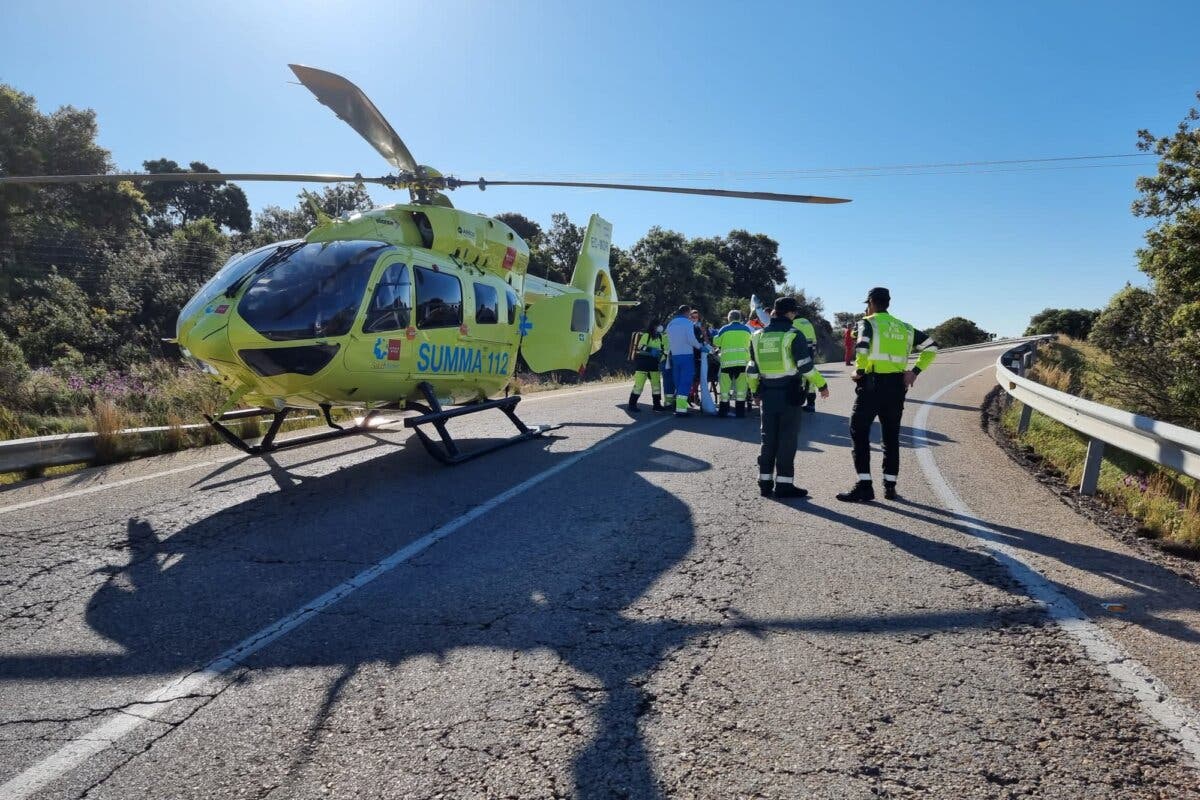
[750,297,829,498]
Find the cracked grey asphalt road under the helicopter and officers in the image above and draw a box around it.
[0,350,1200,800]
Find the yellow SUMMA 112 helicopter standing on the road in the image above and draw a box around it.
[0,65,847,464]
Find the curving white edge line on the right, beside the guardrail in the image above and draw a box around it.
[913,365,1200,768]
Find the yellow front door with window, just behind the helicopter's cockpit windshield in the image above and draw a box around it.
[346,259,414,375]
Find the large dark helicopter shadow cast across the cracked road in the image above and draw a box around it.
[0,420,1041,798]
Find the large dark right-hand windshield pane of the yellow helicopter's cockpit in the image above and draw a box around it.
[238,241,394,342]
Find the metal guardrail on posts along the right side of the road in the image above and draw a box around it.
[996,337,1200,494]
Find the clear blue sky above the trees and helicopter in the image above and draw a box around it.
[0,0,1200,333]
